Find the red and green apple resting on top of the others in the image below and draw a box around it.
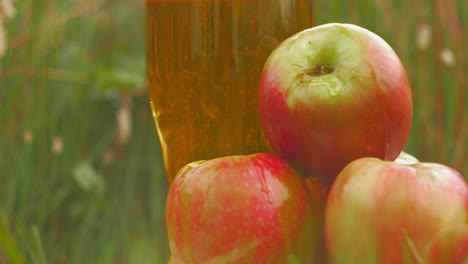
[259,23,413,184]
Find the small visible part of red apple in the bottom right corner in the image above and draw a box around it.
[424,228,468,264]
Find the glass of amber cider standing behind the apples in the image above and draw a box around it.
[146,0,313,182]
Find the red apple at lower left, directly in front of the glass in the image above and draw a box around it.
[166,153,323,264]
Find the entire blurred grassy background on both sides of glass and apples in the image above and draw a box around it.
[0,0,468,264]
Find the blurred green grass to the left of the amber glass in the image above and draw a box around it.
[0,0,168,264]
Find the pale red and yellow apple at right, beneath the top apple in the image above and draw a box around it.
[325,158,468,264]
